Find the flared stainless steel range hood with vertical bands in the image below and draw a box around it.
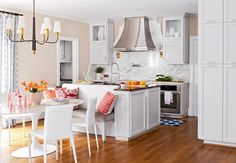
[114,16,156,52]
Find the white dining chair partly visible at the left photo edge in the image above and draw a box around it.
[0,93,25,145]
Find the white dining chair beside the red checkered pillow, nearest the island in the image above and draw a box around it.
[72,98,99,157]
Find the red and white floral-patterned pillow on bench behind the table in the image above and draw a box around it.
[56,88,79,99]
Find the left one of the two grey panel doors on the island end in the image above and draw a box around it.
[130,91,146,136]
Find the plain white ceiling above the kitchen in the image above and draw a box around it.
[0,0,198,21]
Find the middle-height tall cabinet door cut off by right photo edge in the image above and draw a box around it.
[224,23,236,64]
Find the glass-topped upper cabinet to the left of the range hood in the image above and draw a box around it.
[90,19,114,64]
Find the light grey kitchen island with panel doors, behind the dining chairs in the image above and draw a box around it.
[63,84,160,141]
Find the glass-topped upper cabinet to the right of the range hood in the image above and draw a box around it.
[163,14,188,64]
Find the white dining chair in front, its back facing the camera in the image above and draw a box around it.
[29,104,77,163]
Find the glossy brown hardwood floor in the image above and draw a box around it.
[1,118,236,163]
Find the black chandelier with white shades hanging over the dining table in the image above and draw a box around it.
[5,0,61,54]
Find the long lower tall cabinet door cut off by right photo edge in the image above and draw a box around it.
[223,63,236,143]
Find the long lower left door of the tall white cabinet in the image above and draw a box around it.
[198,64,223,141]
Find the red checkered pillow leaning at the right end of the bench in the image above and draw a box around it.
[97,92,117,115]
